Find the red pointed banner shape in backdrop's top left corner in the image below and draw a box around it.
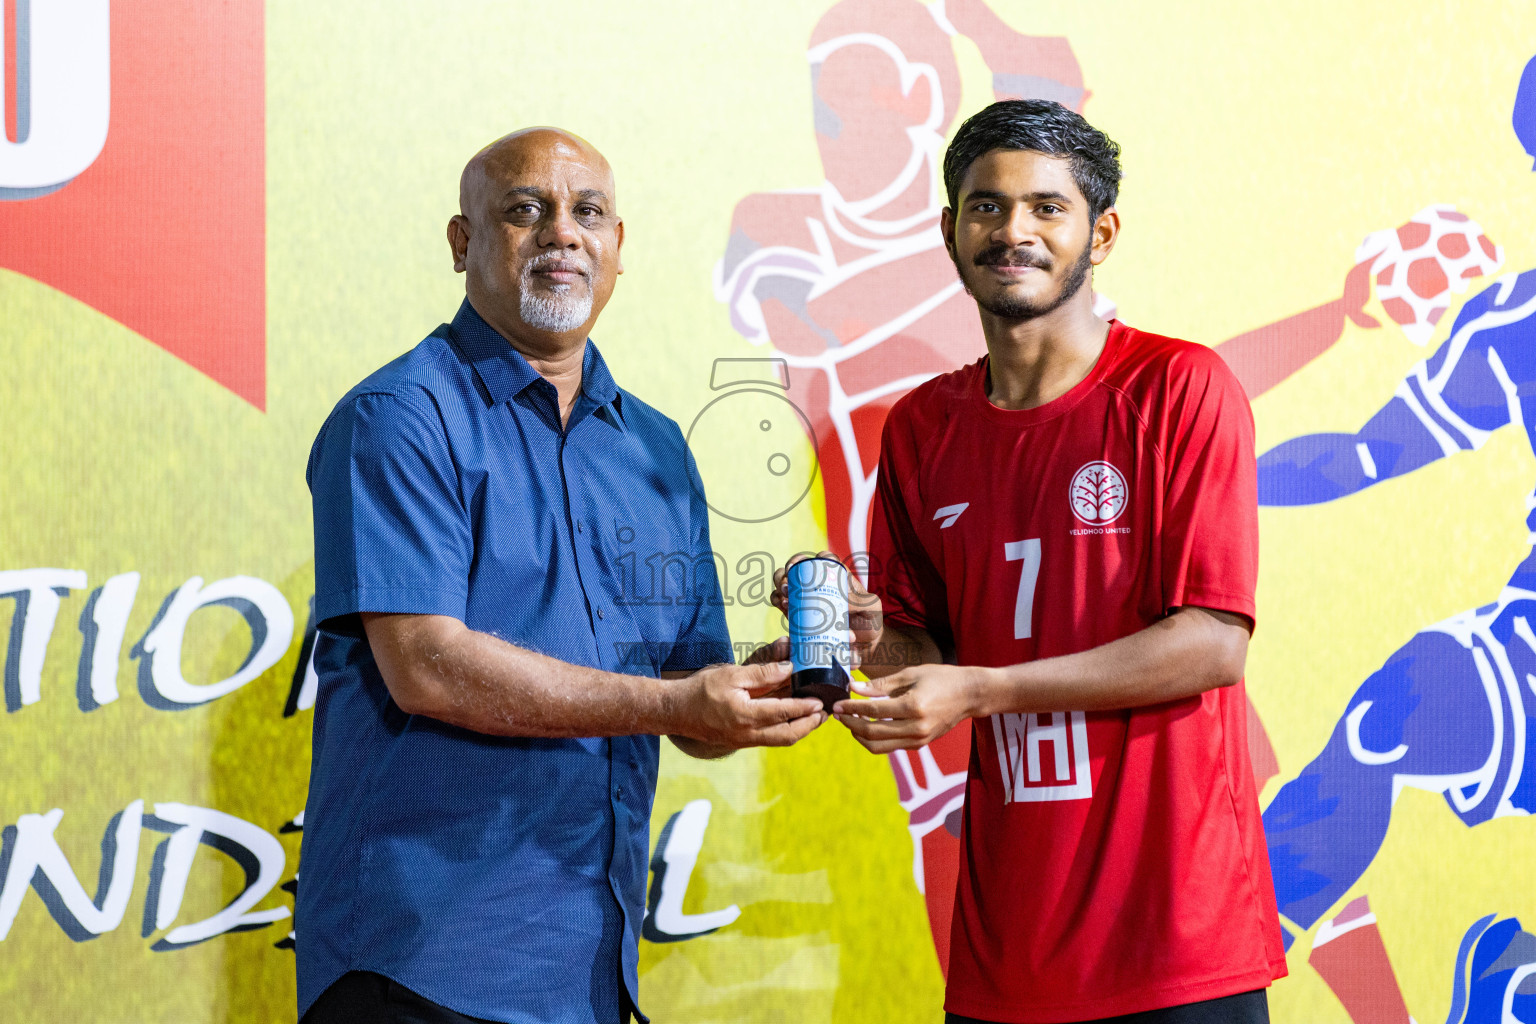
[0,0,266,410]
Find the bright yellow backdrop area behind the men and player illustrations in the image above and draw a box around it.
[0,0,1536,1024]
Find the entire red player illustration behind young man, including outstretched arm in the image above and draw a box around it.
[714,0,1462,969]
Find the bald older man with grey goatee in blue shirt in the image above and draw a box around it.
[295,129,825,1024]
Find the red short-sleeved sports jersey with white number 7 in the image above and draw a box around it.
[871,321,1286,1024]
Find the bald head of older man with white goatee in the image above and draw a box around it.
[449,127,624,355]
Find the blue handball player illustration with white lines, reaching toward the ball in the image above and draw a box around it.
[1258,58,1536,951]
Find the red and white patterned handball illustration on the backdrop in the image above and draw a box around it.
[1355,206,1504,345]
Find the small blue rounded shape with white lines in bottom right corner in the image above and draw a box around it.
[1445,913,1536,1024]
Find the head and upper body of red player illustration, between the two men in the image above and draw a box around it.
[714,0,1093,568]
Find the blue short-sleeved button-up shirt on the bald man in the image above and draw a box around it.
[295,302,731,1024]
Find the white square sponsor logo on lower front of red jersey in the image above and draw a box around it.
[992,711,1094,803]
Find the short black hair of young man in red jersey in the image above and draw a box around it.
[945,100,1120,223]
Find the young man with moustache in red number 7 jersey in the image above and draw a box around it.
[792,100,1286,1024]
